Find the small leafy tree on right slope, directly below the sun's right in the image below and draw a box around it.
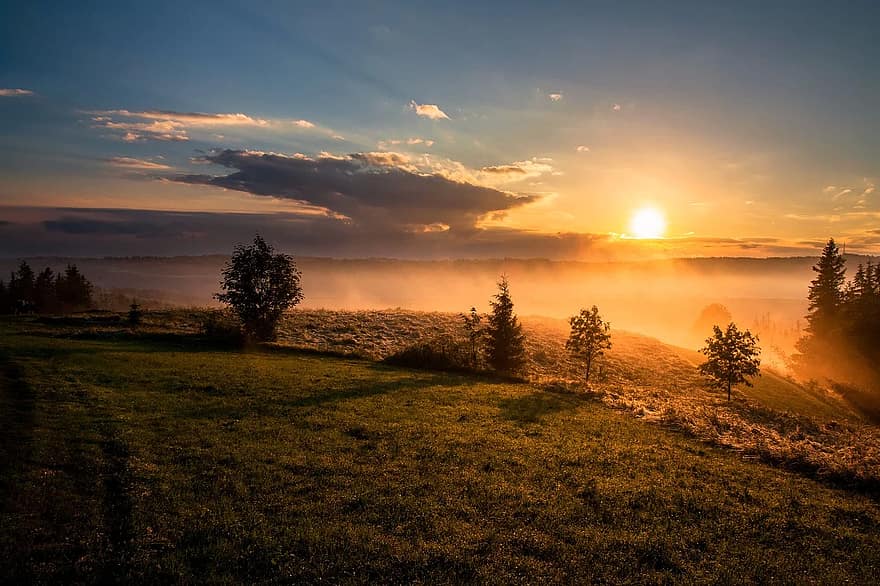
[700,322,761,401]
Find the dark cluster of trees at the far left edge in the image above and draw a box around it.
[0,262,94,314]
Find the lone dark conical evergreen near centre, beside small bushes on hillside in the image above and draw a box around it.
[486,275,526,374]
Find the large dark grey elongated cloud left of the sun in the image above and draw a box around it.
[169,150,538,231]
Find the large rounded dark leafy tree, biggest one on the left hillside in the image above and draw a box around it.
[214,234,303,340]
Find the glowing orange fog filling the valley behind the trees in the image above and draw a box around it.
[0,256,828,353]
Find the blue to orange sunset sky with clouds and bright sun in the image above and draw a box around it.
[0,0,880,260]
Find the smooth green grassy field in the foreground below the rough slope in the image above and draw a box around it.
[0,322,880,584]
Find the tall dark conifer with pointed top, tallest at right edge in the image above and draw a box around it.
[807,238,846,336]
